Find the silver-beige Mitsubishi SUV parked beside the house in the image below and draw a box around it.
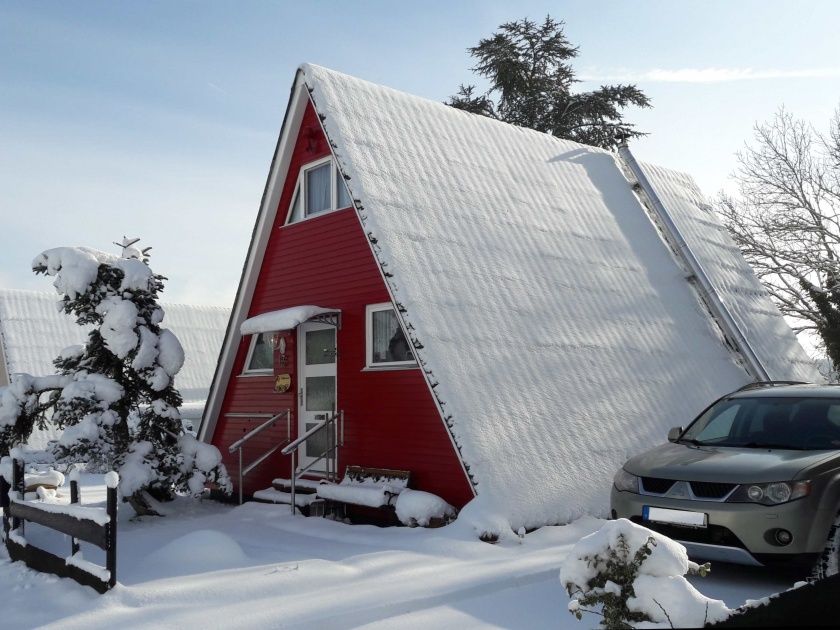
[611,382,840,575]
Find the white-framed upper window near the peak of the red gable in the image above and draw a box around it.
[286,157,352,223]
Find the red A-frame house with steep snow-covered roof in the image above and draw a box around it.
[200,65,819,528]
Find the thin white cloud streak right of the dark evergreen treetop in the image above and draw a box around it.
[580,67,840,83]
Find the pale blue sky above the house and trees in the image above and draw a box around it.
[0,0,840,305]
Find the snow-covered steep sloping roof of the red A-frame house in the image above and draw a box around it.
[300,65,819,528]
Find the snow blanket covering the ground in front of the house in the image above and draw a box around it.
[0,475,795,630]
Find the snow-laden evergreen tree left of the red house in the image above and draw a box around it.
[0,239,231,508]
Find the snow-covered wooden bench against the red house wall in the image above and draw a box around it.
[317,466,411,509]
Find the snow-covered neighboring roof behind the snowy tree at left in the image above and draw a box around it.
[0,289,230,404]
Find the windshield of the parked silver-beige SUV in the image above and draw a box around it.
[679,397,840,450]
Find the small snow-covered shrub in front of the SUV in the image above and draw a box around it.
[560,519,731,628]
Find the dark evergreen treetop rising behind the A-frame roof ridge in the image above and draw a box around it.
[447,16,650,149]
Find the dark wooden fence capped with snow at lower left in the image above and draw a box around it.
[0,459,119,593]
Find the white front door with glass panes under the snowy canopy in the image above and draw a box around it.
[298,323,336,471]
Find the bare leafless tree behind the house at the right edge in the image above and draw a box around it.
[715,108,840,363]
